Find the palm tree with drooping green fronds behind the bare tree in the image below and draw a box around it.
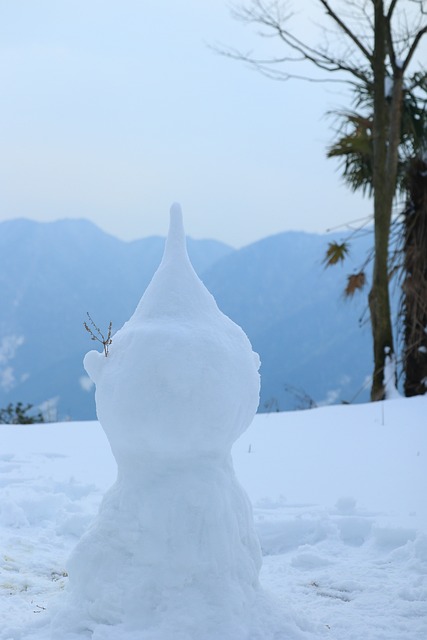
[325,73,427,395]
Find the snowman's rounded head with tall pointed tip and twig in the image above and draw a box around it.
[84,204,259,461]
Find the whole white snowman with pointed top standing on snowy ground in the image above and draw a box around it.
[56,204,261,640]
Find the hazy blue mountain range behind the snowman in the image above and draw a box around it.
[0,220,378,420]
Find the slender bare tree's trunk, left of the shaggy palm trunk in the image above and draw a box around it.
[369,0,395,400]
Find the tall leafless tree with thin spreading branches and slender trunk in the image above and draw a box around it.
[221,0,427,400]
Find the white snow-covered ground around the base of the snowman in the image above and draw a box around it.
[0,397,427,640]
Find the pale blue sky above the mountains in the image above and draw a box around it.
[0,0,424,247]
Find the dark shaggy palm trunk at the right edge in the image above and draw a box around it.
[402,158,427,396]
